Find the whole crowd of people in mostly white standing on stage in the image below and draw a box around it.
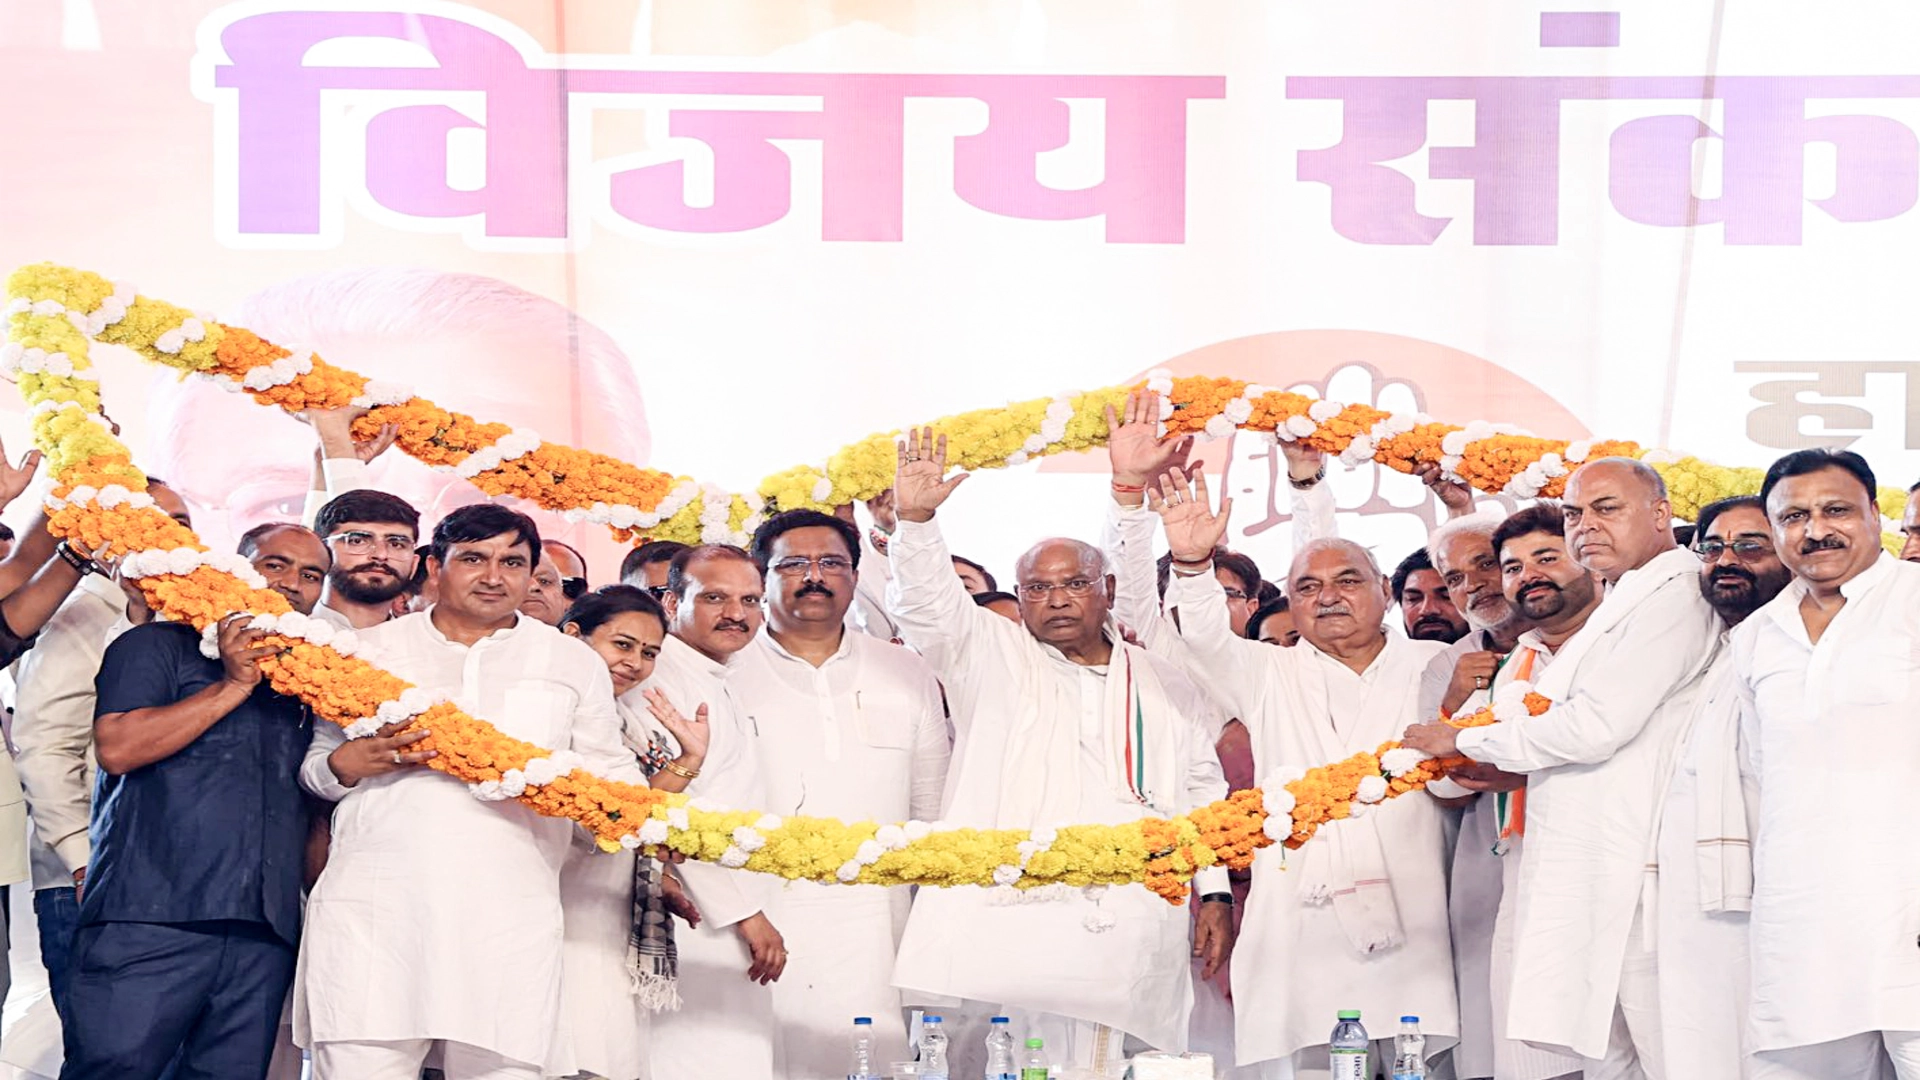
[0,394,1920,1080]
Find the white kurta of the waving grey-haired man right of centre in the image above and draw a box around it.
[1167,575,1459,1065]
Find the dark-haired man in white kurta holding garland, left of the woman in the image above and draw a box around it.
[294,503,645,1080]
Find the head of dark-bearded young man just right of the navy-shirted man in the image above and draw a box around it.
[313,488,420,630]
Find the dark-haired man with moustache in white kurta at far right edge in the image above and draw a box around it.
[1732,450,1920,1080]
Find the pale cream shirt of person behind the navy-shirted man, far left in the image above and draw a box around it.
[13,575,127,890]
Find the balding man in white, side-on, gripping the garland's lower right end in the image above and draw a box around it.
[1404,457,1720,1078]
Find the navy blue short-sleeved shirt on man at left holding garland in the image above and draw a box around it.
[81,623,313,944]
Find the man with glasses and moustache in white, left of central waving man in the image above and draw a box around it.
[728,509,948,1076]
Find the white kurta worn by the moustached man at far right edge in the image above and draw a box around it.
[1734,555,1920,1051]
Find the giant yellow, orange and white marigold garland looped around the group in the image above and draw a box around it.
[0,263,1903,903]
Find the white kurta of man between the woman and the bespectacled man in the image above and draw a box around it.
[628,636,783,1080]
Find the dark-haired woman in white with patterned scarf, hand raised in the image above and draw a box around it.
[547,584,707,1080]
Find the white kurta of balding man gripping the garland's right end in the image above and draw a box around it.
[1459,548,1720,1059]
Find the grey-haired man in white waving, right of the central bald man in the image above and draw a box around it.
[1152,469,1459,1076]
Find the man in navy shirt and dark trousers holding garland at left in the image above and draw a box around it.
[60,525,328,1080]
